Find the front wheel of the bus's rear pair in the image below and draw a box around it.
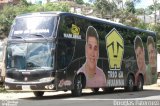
[125,75,134,92]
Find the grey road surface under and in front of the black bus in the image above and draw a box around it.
[0,86,160,106]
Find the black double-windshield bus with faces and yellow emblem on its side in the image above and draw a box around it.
[5,12,157,97]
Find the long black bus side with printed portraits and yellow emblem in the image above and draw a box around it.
[57,13,157,96]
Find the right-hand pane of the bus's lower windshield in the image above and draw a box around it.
[26,43,53,69]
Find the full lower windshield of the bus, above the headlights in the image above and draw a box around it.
[7,42,54,70]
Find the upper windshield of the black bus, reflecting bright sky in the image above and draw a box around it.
[10,16,56,38]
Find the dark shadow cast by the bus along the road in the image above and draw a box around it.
[20,89,160,100]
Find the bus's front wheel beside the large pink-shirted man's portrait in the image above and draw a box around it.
[72,75,82,96]
